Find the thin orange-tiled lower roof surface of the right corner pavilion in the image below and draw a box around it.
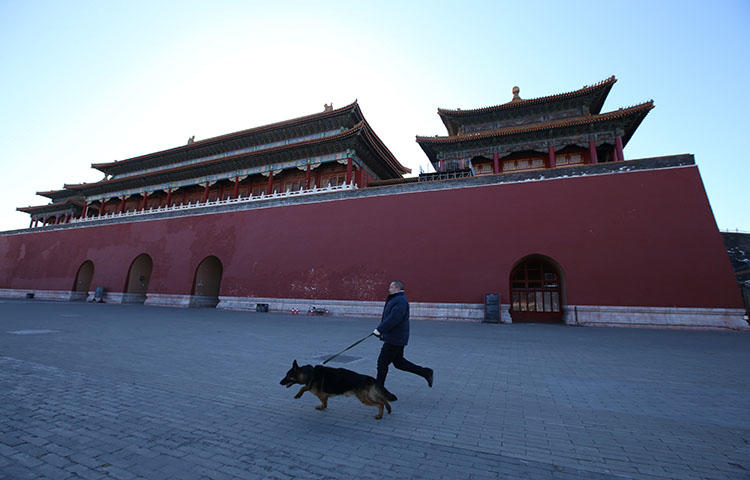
[417,100,654,143]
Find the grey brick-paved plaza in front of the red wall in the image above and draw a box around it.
[0,300,750,480]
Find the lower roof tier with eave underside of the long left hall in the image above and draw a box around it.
[65,120,411,195]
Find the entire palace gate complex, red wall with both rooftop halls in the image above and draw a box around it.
[0,77,746,328]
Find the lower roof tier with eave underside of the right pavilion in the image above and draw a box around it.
[417,100,654,161]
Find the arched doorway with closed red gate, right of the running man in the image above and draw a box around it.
[510,255,563,323]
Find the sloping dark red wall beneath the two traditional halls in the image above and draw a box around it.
[0,167,742,308]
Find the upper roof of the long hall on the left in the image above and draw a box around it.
[91,100,363,175]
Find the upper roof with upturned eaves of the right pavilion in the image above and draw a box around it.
[438,75,617,134]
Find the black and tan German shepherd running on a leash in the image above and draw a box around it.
[279,360,398,420]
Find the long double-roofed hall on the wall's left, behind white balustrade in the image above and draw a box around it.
[18,102,410,227]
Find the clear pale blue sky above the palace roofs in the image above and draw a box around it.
[0,0,750,231]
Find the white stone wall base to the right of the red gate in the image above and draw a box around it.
[563,305,749,330]
